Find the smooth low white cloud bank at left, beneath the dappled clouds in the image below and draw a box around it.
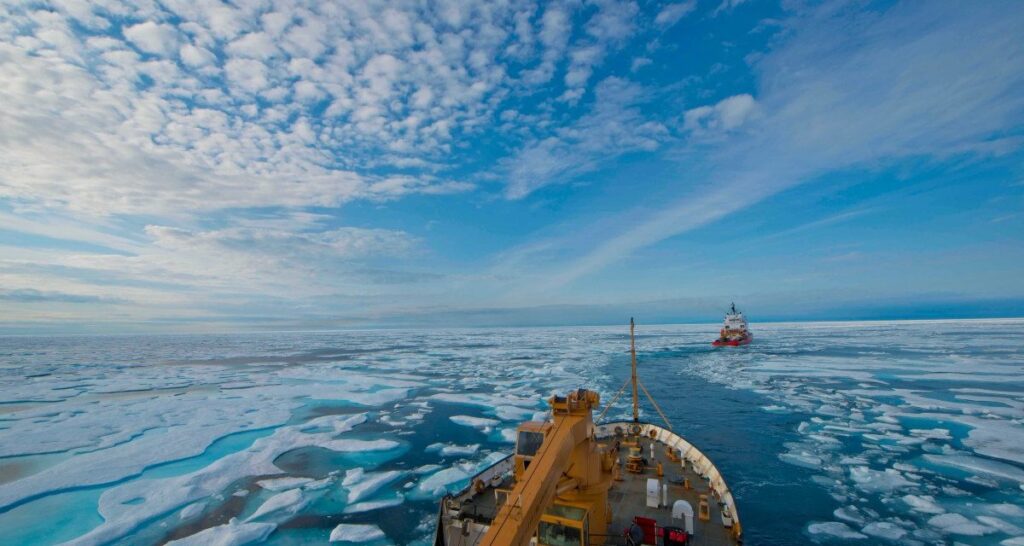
[0,219,422,318]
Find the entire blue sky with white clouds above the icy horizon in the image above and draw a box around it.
[0,0,1024,333]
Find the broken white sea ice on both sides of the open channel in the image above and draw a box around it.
[0,323,1024,545]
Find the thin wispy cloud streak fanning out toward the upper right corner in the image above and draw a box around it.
[550,3,1024,287]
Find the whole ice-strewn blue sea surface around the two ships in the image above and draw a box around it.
[0,321,1024,546]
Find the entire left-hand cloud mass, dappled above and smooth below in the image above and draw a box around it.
[0,0,688,327]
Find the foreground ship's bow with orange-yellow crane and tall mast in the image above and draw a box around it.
[435,319,742,546]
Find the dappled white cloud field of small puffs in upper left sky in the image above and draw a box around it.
[0,1,569,223]
